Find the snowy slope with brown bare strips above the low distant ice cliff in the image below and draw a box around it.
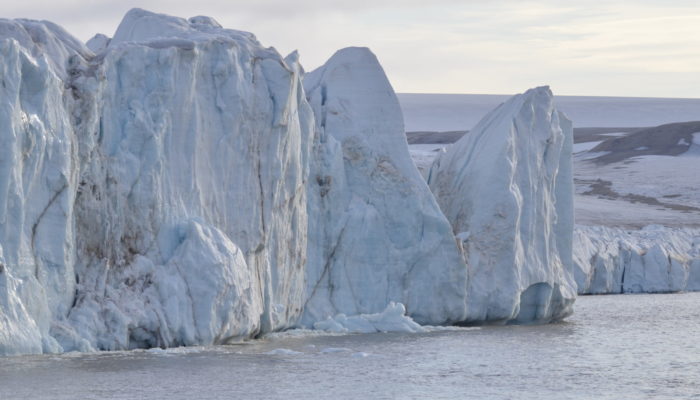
[574,143,700,229]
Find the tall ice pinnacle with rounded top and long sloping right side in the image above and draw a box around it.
[302,48,466,325]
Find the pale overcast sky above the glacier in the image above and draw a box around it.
[0,0,700,98]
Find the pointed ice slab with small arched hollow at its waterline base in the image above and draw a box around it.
[428,87,576,321]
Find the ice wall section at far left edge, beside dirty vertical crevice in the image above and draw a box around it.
[0,20,90,354]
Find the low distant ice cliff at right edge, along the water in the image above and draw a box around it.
[574,225,700,294]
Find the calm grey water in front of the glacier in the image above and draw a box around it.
[0,293,700,400]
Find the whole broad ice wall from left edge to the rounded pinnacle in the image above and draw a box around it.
[0,10,313,353]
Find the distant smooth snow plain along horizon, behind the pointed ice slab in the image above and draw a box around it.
[398,93,700,132]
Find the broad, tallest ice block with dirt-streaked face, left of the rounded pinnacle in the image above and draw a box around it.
[55,9,313,349]
